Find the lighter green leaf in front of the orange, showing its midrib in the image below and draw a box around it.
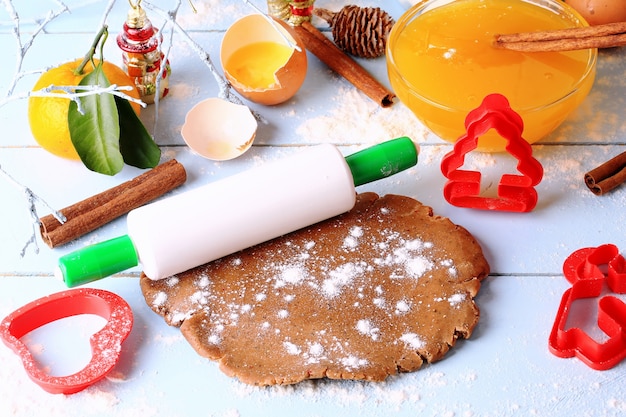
[68,64,124,175]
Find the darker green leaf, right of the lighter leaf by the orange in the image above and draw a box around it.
[115,97,161,168]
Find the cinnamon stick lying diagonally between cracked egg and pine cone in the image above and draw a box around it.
[294,21,395,107]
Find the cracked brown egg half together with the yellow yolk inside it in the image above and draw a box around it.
[220,14,307,105]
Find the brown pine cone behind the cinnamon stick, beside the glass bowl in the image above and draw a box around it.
[313,5,394,58]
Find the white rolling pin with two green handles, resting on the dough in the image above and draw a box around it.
[56,137,418,287]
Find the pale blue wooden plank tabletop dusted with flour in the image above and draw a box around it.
[0,0,626,417]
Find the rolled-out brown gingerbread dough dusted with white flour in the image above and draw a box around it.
[141,193,489,385]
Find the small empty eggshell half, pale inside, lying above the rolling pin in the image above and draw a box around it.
[181,98,258,161]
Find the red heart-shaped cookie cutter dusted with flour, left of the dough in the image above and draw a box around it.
[0,288,133,394]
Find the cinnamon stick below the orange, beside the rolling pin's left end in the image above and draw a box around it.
[39,159,187,248]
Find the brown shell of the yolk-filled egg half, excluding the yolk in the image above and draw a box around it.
[220,14,307,105]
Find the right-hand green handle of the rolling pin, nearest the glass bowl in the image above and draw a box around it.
[346,136,419,187]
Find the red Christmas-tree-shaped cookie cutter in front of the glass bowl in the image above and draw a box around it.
[441,94,543,212]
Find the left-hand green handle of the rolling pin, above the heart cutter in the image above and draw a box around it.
[55,235,139,288]
